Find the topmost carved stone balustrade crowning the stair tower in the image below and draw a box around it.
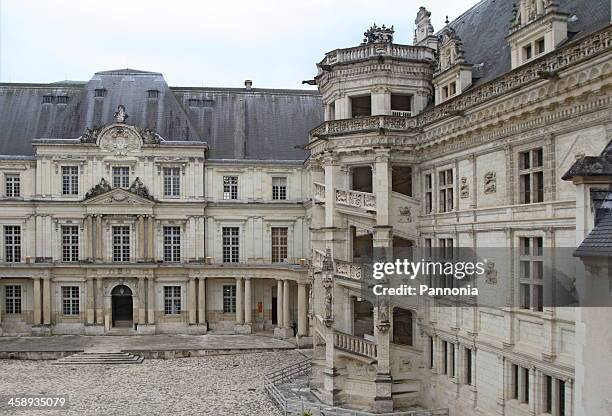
[319,43,434,65]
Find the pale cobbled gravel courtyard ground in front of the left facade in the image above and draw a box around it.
[0,350,304,416]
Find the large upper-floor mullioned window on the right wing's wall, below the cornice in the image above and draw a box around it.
[519,148,544,204]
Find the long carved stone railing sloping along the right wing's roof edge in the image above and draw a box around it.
[416,25,612,127]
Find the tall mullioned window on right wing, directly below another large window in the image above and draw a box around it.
[519,237,544,312]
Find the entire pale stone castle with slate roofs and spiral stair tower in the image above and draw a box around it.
[0,0,612,416]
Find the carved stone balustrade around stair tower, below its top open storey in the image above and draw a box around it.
[310,115,416,141]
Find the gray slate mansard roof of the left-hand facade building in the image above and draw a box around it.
[0,69,322,160]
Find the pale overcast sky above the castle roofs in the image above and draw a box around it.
[0,0,478,88]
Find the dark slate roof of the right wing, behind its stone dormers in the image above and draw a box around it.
[449,0,610,85]
